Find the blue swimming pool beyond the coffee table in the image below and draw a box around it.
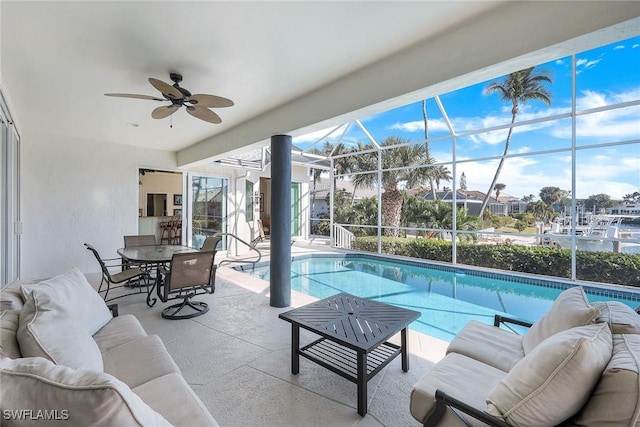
[236,254,640,341]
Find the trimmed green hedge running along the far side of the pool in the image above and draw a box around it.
[351,237,640,287]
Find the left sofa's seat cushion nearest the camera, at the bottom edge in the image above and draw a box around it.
[133,373,218,427]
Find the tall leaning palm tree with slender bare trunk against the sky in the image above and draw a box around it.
[479,67,551,217]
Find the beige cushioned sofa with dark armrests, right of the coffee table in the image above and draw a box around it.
[410,286,640,427]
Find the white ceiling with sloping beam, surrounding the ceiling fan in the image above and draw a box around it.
[0,1,640,164]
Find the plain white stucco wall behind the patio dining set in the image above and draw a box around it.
[21,132,176,279]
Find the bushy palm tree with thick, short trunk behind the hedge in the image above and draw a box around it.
[351,136,431,237]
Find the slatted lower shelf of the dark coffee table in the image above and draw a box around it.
[298,338,402,384]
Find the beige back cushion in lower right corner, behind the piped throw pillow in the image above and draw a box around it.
[572,334,640,427]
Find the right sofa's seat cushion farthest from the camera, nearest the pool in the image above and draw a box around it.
[447,320,524,372]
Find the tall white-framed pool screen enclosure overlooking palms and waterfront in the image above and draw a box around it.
[219,37,640,290]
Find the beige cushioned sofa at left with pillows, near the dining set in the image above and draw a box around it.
[0,269,217,426]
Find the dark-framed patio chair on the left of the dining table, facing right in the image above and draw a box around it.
[84,243,149,302]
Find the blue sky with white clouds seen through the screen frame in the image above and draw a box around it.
[294,37,640,199]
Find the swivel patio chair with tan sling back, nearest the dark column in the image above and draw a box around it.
[156,251,217,319]
